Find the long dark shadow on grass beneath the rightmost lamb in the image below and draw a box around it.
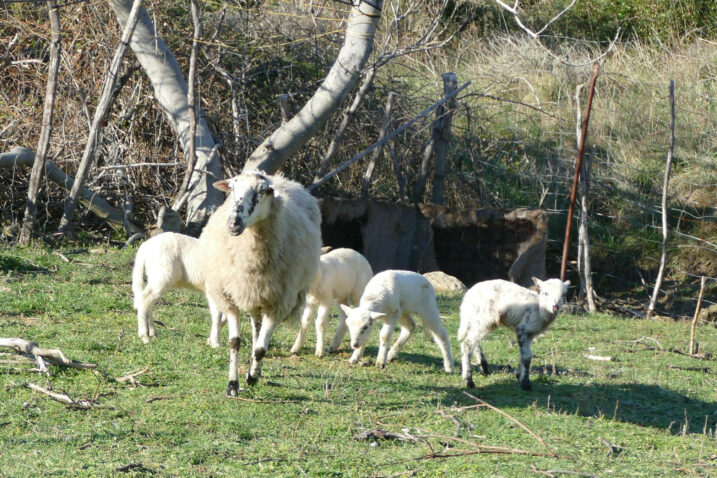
[426,374,717,434]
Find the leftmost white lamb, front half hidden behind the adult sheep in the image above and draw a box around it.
[132,232,222,348]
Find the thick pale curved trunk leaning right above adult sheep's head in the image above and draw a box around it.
[244,0,383,173]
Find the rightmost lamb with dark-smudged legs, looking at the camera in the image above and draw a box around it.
[458,278,570,390]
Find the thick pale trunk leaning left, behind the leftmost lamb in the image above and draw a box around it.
[109,0,224,234]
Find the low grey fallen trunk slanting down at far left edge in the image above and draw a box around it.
[0,147,142,236]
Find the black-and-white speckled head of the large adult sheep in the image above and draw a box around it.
[214,172,274,236]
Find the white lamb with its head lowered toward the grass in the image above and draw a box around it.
[341,270,453,373]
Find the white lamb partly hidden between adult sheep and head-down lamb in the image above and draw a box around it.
[291,248,373,357]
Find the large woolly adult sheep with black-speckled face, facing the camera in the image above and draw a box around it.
[199,171,321,396]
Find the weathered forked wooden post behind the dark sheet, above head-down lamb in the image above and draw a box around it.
[413,72,458,204]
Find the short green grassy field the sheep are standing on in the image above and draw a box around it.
[0,248,717,477]
